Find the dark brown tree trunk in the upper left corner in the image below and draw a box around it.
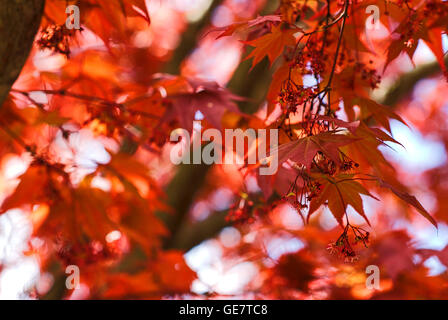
[0,0,45,106]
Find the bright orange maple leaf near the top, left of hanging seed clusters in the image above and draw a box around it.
[246,24,297,68]
